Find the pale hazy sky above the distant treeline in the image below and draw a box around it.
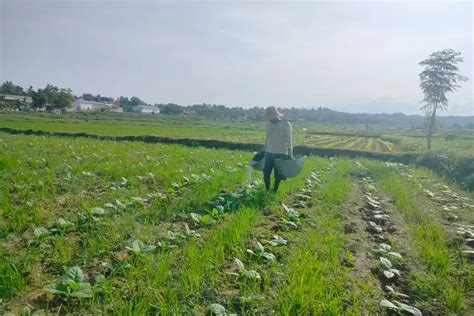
[0,0,474,115]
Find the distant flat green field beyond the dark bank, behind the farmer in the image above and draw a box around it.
[0,112,474,157]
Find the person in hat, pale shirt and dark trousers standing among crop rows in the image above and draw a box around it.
[263,106,293,192]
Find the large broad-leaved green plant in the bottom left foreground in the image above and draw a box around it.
[43,266,93,298]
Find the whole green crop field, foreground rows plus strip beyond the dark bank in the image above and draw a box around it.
[0,114,474,315]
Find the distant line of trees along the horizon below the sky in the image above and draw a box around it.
[0,81,474,129]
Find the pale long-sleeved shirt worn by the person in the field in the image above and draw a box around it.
[264,121,293,155]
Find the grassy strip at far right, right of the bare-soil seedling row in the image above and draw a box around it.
[367,162,474,314]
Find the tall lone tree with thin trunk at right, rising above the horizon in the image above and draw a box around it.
[419,49,468,150]
